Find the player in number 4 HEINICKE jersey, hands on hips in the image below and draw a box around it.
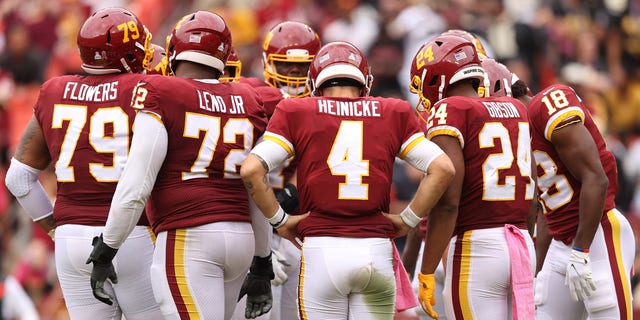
[241,42,454,319]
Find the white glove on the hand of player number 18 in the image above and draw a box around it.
[564,249,596,301]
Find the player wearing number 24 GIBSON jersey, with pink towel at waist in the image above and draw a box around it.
[411,35,536,319]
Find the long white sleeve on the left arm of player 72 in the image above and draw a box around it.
[102,111,169,249]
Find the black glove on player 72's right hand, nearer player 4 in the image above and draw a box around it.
[238,253,275,319]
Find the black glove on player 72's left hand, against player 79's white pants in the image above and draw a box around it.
[87,235,118,305]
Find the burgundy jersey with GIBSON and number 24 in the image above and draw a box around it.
[427,97,534,234]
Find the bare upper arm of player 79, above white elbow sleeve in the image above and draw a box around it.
[13,116,51,170]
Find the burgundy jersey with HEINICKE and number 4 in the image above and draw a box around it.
[265,97,426,237]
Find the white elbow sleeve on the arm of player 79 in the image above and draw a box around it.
[5,158,53,221]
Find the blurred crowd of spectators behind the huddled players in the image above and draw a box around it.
[0,0,640,319]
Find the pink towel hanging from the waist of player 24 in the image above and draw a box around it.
[504,224,535,320]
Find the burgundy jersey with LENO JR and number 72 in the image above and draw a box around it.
[132,77,267,233]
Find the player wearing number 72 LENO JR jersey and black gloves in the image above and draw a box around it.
[85,11,273,319]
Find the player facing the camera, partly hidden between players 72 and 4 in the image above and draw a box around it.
[228,21,320,320]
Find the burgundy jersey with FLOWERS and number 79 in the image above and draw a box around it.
[34,74,146,226]
